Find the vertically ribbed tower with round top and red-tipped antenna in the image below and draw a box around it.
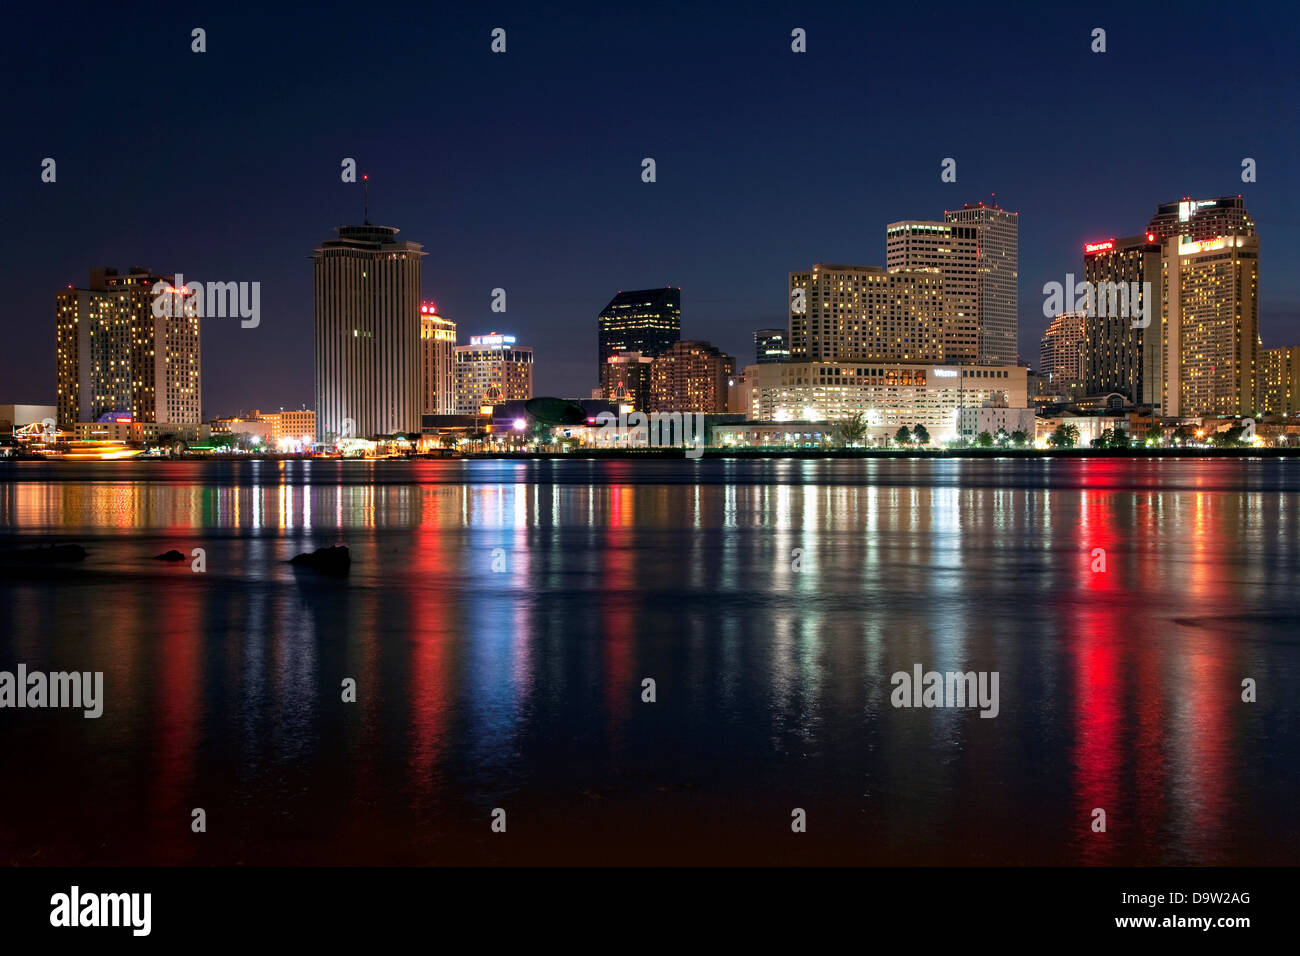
[312,224,425,441]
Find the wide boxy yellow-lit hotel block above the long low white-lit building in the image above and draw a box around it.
[789,263,944,362]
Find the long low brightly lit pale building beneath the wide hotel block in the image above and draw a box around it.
[732,362,1032,445]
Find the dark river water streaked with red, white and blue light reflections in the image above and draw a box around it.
[0,459,1300,864]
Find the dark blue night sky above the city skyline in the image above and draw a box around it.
[0,3,1300,415]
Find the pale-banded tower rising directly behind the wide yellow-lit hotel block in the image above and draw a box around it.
[885,220,980,363]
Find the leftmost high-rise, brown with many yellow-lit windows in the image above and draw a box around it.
[55,268,202,429]
